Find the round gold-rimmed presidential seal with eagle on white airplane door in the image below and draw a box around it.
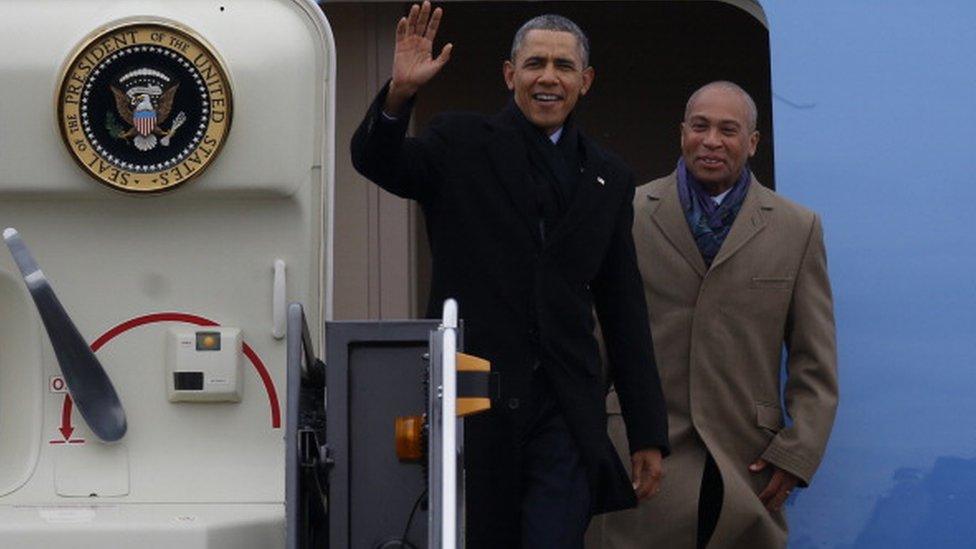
[57,21,232,193]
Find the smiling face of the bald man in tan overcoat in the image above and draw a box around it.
[681,86,759,194]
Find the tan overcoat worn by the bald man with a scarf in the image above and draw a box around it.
[587,174,837,549]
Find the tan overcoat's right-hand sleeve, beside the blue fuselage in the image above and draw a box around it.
[762,216,838,486]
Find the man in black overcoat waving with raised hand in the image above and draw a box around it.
[352,2,668,549]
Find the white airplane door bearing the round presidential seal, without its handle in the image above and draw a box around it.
[0,0,335,548]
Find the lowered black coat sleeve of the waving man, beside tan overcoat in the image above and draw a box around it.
[592,180,670,455]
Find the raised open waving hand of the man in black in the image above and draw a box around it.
[383,1,454,115]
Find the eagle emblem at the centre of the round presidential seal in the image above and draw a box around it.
[106,68,186,152]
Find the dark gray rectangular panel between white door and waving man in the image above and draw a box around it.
[325,320,466,549]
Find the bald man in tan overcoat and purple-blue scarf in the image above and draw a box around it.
[588,82,837,549]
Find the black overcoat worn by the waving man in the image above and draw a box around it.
[352,85,668,522]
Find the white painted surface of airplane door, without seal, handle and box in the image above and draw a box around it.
[0,0,335,549]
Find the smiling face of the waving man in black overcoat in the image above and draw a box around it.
[504,29,594,134]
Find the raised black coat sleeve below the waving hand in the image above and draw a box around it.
[350,82,444,201]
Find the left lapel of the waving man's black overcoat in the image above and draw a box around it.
[488,109,540,241]
